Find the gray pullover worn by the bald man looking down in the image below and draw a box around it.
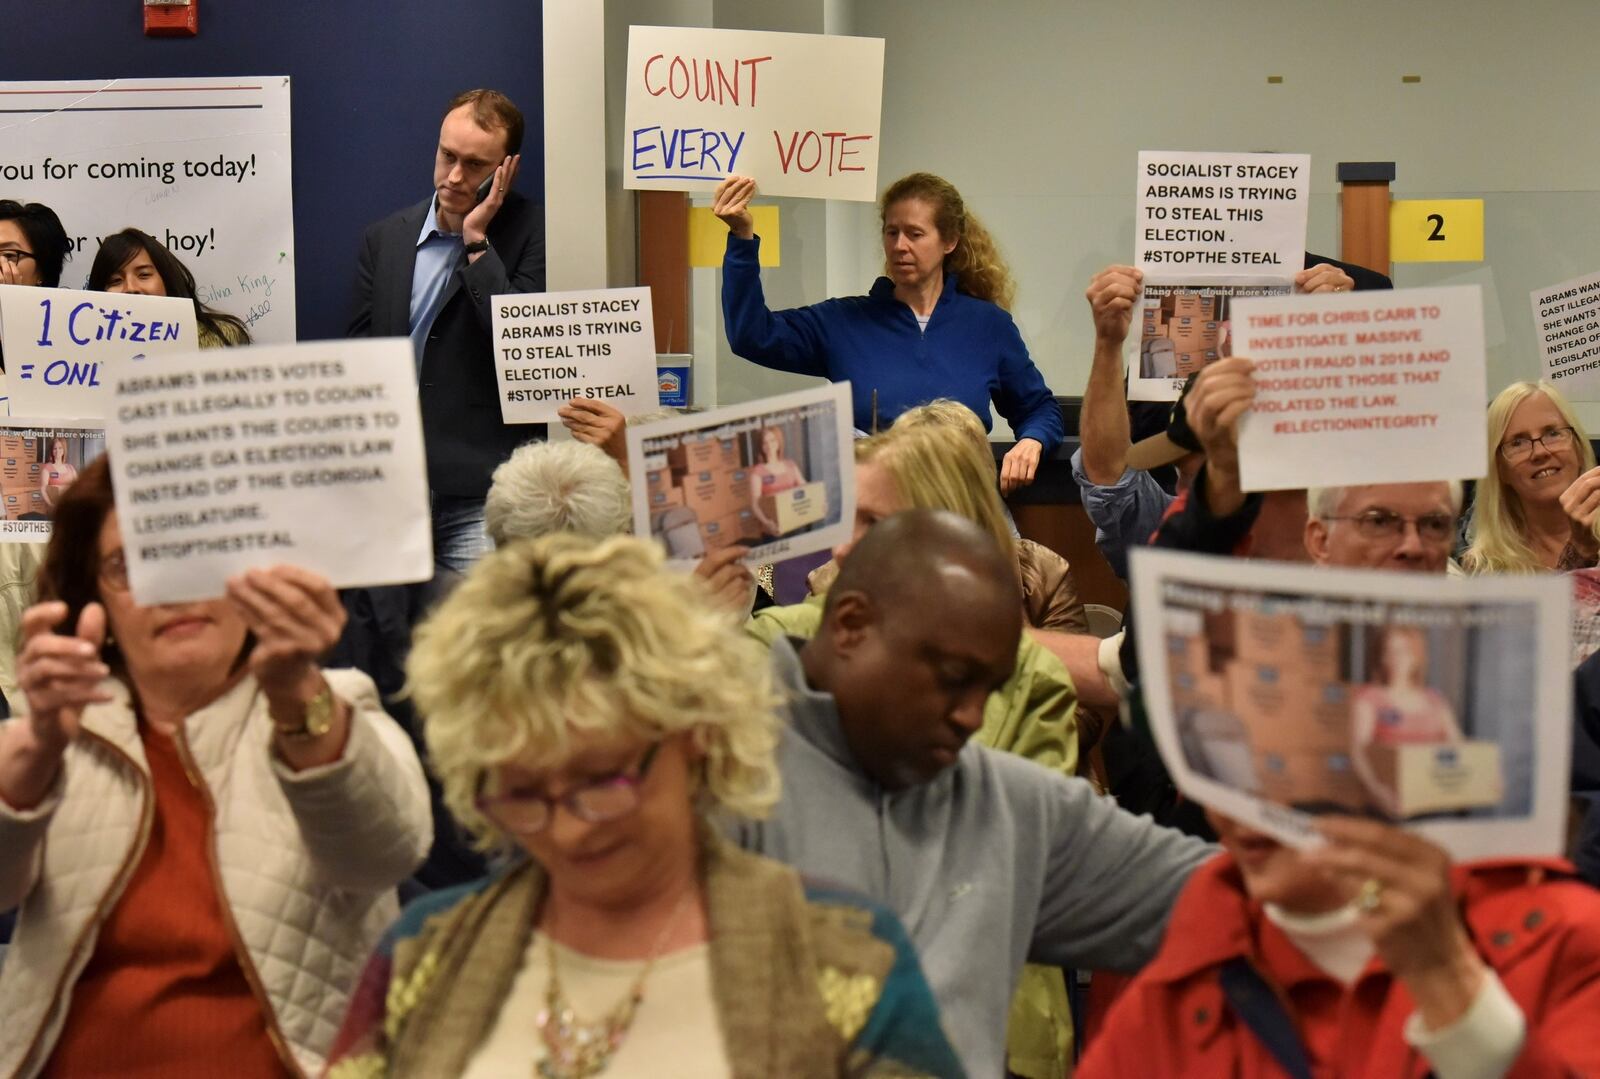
[734,639,1214,1077]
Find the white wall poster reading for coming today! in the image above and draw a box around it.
[0,75,294,343]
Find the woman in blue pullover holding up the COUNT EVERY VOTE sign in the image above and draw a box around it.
[712,173,1064,493]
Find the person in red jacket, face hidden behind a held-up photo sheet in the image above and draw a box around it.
[1078,813,1600,1079]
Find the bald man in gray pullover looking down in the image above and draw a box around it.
[739,509,1213,1077]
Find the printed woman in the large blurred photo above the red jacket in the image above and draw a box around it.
[1350,626,1462,815]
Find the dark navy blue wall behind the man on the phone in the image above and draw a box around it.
[0,0,544,339]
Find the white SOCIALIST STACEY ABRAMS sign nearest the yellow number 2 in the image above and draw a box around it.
[1133,150,1310,280]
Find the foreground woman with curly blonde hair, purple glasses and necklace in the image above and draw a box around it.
[318,535,960,1079]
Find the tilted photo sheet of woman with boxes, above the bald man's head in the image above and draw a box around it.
[627,383,856,568]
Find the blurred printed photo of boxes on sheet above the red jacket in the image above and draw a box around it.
[1166,589,1536,821]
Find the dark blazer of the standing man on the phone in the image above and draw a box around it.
[349,192,544,498]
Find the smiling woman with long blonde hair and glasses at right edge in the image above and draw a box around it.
[1461,379,1600,573]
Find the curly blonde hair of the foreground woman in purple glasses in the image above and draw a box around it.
[406,533,779,850]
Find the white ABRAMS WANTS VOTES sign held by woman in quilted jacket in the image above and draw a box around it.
[106,338,434,604]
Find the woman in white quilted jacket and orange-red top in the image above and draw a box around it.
[0,458,432,1079]
